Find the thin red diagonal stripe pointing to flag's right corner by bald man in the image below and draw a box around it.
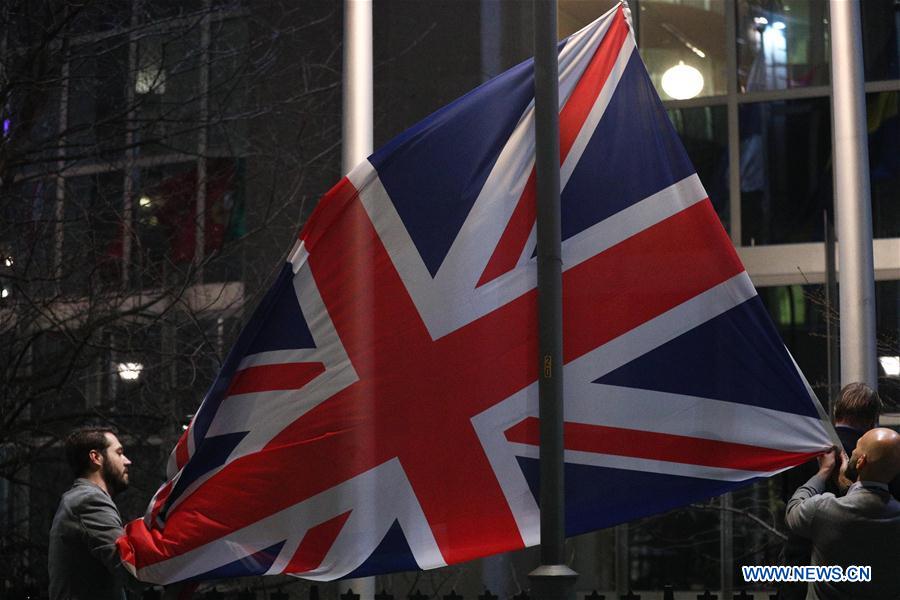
[506,417,821,473]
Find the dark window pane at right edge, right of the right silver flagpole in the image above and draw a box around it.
[866,91,900,237]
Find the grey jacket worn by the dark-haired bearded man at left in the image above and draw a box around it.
[48,479,130,600]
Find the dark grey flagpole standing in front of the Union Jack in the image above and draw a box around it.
[528,0,578,600]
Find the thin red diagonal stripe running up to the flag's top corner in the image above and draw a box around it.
[476,8,628,287]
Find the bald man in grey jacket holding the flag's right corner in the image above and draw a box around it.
[785,428,900,600]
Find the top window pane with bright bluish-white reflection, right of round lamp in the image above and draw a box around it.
[737,0,831,92]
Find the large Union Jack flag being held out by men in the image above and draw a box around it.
[119,6,832,583]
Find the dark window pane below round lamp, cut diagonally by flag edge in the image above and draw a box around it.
[669,106,731,229]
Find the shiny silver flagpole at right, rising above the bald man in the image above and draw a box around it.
[830,0,878,388]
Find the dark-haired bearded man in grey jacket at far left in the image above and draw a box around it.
[48,429,133,600]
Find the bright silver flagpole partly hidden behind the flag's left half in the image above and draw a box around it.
[338,0,375,600]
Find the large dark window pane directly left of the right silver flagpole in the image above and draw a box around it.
[739,98,833,246]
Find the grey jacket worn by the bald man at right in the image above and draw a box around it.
[785,475,900,600]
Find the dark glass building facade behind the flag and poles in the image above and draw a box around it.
[0,0,900,598]
